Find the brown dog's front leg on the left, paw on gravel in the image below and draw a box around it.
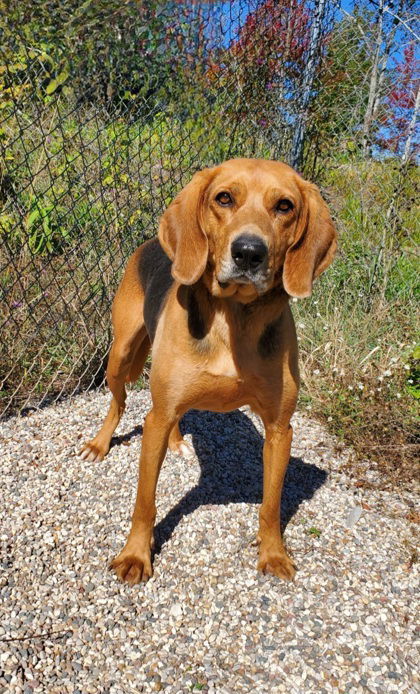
[110,409,176,585]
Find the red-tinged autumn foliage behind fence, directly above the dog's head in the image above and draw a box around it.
[207,0,310,151]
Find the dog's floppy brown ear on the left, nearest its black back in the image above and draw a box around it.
[158,169,212,284]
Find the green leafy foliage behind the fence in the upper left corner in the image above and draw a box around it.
[0,0,199,117]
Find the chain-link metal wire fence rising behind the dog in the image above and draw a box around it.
[0,0,419,416]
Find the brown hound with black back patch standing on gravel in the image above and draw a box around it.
[82,159,336,584]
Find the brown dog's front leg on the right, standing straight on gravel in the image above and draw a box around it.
[258,423,296,579]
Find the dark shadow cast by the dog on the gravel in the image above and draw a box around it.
[144,410,327,554]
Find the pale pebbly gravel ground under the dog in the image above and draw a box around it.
[0,391,419,694]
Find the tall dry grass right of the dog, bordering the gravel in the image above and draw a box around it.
[294,160,420,479]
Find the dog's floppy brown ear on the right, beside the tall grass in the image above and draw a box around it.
[283,179,337,298]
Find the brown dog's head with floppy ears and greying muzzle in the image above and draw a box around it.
[159,159,336,302]
